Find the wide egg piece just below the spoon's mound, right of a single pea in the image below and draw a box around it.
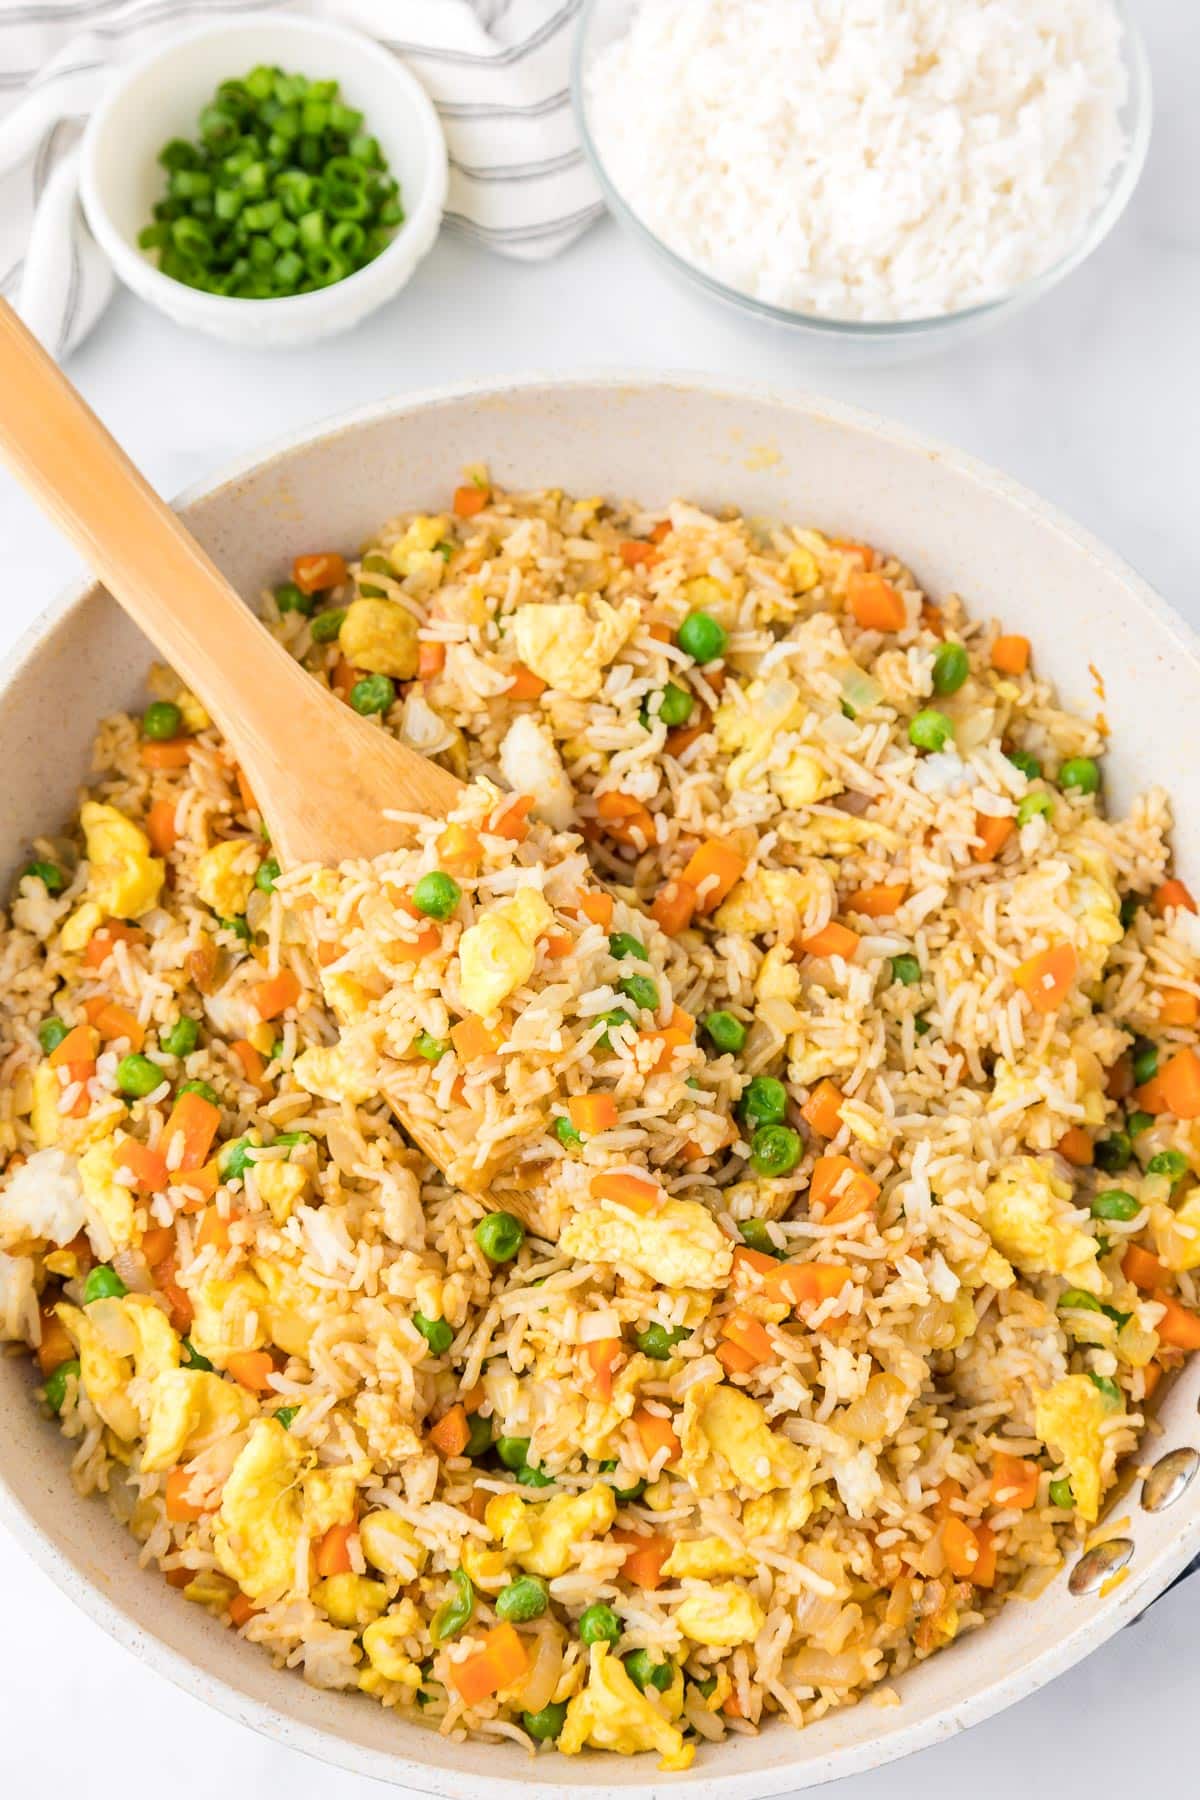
[558,1201,734,1289]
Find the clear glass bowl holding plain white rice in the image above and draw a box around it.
[570,0,1153,360]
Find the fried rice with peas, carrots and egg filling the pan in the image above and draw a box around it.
[0,470,1200,1769]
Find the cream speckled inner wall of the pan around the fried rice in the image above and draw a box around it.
[0,376,1200,1800]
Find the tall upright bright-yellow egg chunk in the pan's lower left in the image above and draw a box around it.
[212,1418,304,1606]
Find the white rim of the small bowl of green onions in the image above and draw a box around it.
[79,13,450,322]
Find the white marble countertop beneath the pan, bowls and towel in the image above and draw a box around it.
[0,0,1200,1800]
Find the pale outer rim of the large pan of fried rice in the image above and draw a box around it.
[0,369,1200,1800]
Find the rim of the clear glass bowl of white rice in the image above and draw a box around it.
[570,0,1155,344]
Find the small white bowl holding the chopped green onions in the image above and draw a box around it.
[79,13,446,349]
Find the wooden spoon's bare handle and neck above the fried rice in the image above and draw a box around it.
[0,301,462,864]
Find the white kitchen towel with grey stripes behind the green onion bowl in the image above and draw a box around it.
[0,0,603,356]
